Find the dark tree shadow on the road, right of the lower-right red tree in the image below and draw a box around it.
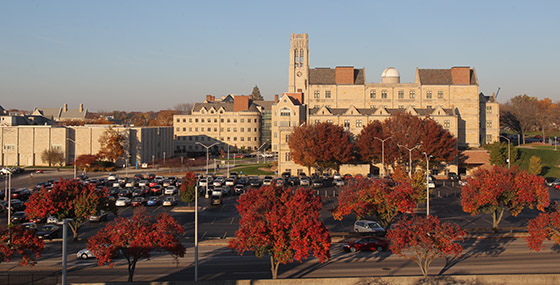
[440,238,513,274]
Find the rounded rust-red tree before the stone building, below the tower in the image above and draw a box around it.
[288,122,354,172]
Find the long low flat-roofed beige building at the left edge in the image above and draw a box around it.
[0,125,173,166]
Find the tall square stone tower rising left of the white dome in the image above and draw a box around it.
[288,34,309,96]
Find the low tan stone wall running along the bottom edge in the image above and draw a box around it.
[74,274,560,285]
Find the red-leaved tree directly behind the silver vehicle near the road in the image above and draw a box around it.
[332,168,424,229]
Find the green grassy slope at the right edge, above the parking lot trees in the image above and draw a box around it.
[514,144,560,178]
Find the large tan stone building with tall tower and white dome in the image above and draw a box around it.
[272,34,499,175]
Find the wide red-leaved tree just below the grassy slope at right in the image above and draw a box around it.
[461,166,550,230]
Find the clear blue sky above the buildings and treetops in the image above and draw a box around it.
[0,0,560,111]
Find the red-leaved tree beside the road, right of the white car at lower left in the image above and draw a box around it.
[87,209,186,282]
